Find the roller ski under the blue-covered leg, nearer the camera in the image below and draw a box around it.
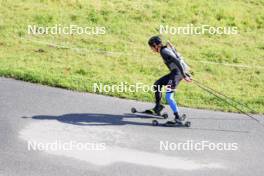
[152,114,191,127]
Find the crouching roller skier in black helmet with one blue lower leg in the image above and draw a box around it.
[148,36,192,124]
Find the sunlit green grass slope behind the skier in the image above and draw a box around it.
[0,0,264,114]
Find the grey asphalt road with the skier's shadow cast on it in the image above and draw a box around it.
[0,78,264,176]
